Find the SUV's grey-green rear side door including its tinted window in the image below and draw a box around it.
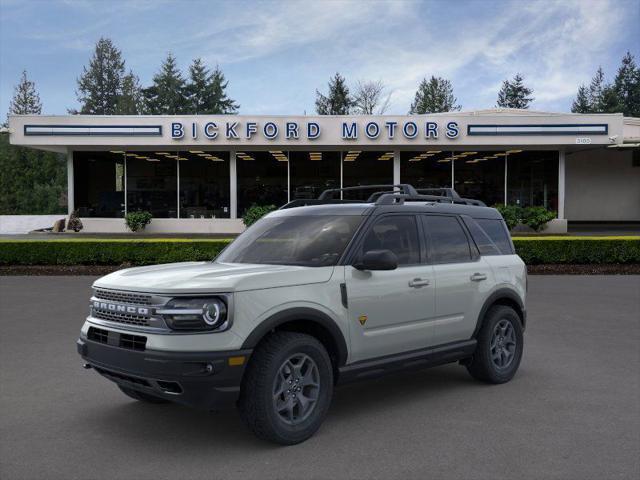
[422,215,493,345]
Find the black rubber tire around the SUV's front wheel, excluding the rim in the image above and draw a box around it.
[238,332,333,445]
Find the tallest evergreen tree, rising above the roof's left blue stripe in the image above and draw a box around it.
[72,38,125,115]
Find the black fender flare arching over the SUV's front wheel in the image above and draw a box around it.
[242,307,348,366]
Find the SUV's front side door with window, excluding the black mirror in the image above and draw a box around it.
[345,214,435,361]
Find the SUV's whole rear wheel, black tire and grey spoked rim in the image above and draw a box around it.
[467,305,524,383]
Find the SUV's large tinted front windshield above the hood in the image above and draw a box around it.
[216,215,362,267]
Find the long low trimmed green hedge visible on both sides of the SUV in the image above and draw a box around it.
[0,236,640,265]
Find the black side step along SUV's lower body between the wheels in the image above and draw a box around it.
[338,339,477,384]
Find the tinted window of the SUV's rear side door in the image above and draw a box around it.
[423,215,471,263]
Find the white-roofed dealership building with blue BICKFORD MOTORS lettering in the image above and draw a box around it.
[9,109,640,233]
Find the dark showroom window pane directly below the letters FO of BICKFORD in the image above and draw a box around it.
[236,151,289,217]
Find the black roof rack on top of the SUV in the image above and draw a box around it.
[280,183,486,210]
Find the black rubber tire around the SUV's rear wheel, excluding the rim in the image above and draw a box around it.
[466,305,524,383]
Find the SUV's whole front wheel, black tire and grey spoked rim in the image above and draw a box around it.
[239,332,333,445]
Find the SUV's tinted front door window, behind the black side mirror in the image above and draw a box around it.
[362,215,420,265]
